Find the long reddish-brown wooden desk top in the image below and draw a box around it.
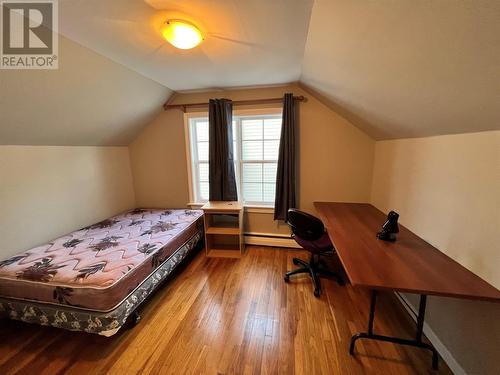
[314,202,500,302]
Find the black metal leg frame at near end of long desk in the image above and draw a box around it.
[349,290,438,370]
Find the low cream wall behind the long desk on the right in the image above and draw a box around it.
[371,131,500,374]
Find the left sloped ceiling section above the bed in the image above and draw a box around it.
[0,37,171,146]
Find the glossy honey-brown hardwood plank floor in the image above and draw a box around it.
[0,247,451,375]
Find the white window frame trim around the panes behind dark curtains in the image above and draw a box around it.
[184,107,282,211]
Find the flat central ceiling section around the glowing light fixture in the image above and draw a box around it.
[59,0,313,91]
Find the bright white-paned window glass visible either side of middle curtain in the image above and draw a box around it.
[188,111,281,206]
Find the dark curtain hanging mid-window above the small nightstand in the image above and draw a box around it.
[208,99,238,201]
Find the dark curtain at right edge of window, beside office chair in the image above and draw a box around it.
[274,94,298,220]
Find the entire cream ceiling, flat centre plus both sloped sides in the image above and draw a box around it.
[0,0,500,145]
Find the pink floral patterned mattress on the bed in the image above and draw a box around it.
[0,209,203,311]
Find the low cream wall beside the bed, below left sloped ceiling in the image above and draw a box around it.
[0,146,135,258]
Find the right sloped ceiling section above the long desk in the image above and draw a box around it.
[301,0,500,139]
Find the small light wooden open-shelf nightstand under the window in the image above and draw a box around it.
[201,201,245,258]
